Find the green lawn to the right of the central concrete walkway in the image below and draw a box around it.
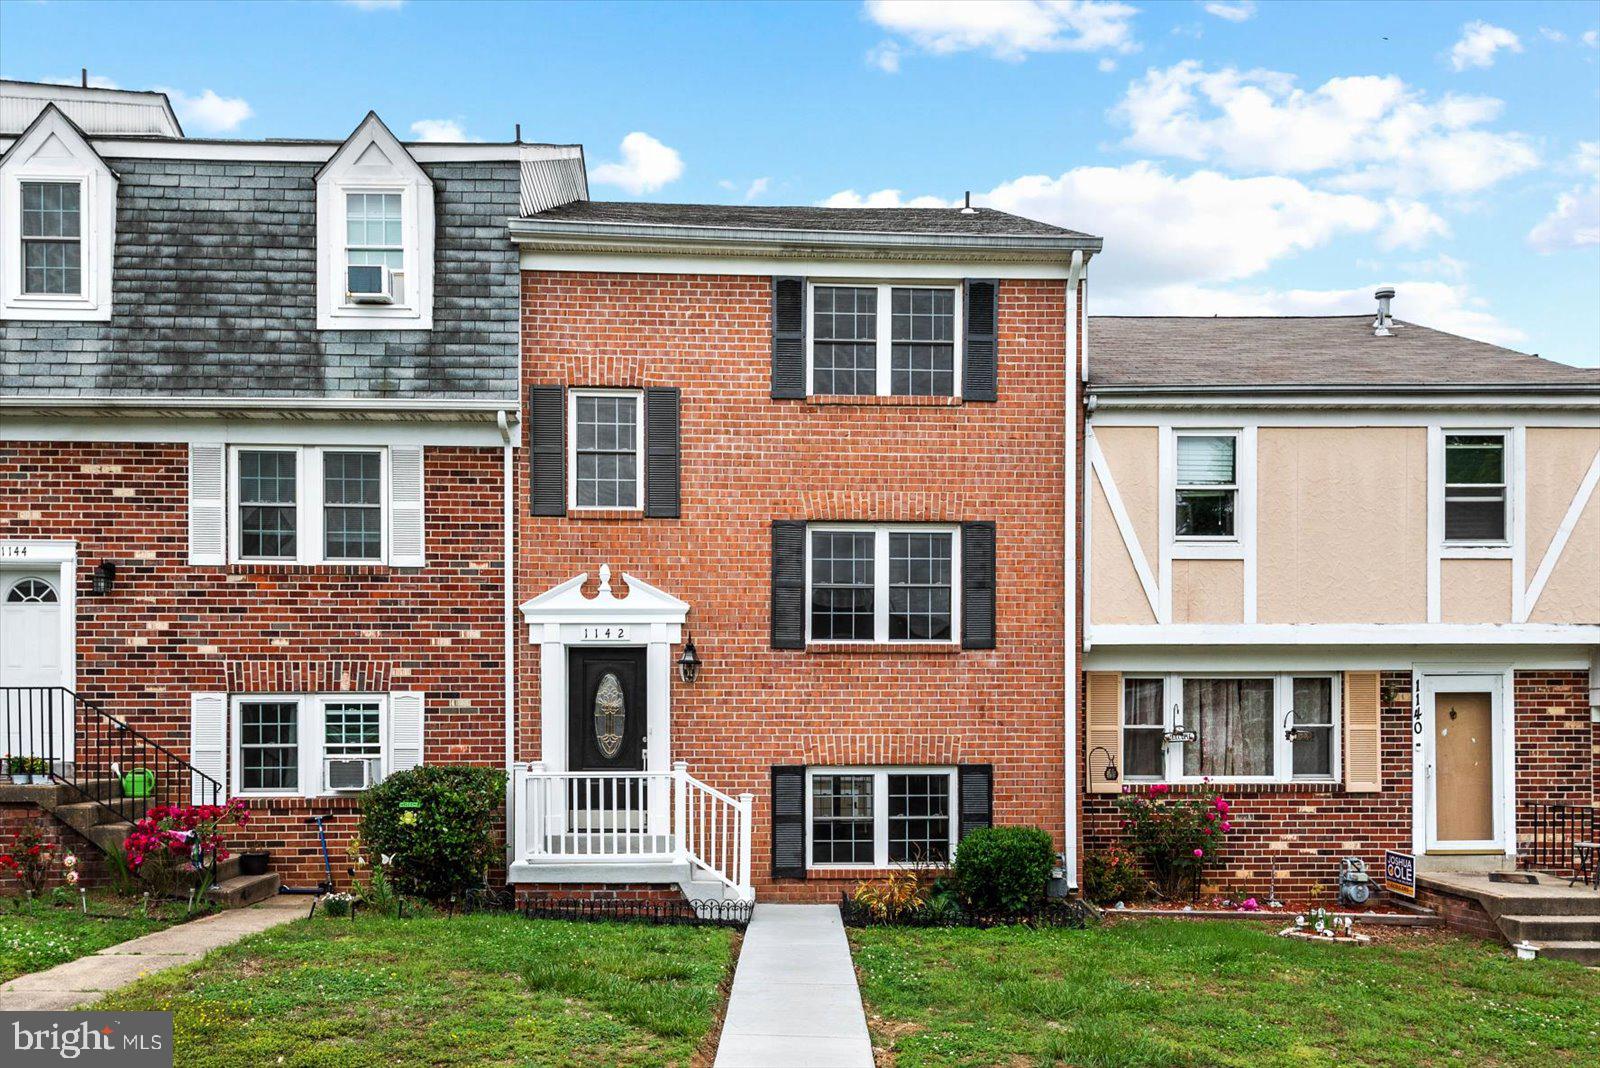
[850,919,1600,1068]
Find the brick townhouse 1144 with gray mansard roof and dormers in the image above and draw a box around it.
[0,83,582,892]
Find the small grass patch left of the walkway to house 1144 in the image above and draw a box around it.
[0,894,181,983]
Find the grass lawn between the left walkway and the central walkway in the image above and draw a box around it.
[96,915,734,1068]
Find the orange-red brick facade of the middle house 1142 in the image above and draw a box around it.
[517,272,1070,900]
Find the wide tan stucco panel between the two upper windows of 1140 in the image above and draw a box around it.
[1256,427,1427,624]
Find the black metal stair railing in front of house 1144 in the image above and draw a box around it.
[0,686,227,822]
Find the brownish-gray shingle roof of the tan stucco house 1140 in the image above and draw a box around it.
[1090,315,1600,389]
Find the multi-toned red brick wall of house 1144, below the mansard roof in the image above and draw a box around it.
[0,430,504,884]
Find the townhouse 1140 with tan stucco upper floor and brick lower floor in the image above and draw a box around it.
[1077,308,1600,900]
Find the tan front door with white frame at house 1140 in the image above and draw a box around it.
[1418,675,1509,854]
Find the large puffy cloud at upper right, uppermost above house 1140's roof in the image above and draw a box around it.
[1112,59,1539,195]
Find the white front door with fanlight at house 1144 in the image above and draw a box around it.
[0,569,72,761]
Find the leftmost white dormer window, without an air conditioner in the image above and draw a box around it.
[0,106,117,321]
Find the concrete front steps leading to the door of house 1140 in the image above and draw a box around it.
[1418,871,1600,967]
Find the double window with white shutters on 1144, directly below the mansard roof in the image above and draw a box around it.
[232,446,387,563]
